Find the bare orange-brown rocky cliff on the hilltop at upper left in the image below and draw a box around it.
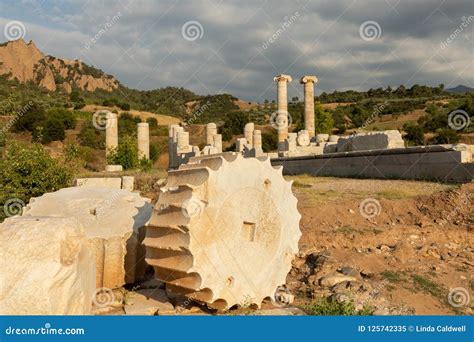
[0,39,119,93]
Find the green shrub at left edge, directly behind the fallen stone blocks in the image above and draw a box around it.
[0,141,73,221]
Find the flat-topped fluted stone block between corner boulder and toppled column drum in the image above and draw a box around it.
[23,186,153,289]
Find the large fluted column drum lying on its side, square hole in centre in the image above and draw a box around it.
[144,153,301,309]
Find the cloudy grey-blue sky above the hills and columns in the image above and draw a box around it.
[0,0,474,101]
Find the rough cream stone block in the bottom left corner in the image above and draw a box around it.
[0,216,96,315]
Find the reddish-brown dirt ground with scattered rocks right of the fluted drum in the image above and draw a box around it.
[287,176,474,315]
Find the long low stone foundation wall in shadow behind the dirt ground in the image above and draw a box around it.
[272,145,474,182]
